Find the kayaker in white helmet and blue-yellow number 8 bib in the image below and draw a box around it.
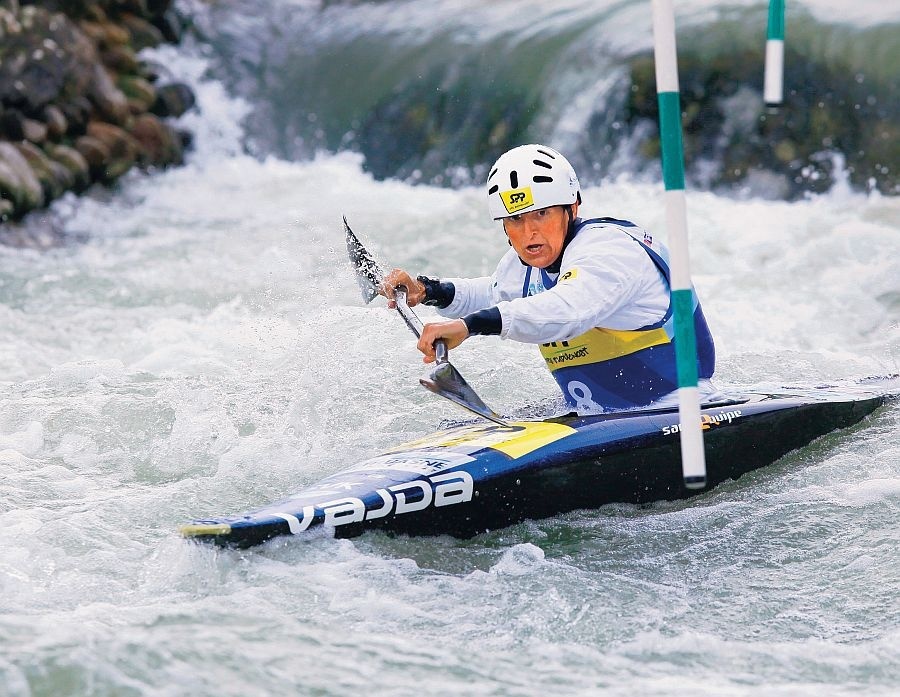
[384,145,715,413]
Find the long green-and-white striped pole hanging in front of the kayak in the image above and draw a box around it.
[653,0,706,489]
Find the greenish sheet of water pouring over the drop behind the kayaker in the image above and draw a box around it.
[179,0,900,198]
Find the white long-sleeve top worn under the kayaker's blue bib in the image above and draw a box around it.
[438,222,669,344]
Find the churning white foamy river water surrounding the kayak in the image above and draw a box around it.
[0,1,900,697]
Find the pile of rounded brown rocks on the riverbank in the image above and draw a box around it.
[0,0,194,242]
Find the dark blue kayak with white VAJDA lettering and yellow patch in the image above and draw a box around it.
[180,376,900,547]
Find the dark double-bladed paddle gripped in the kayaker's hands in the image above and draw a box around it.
[344,217,509,426]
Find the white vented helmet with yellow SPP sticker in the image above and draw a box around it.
[487,145,581,220]
